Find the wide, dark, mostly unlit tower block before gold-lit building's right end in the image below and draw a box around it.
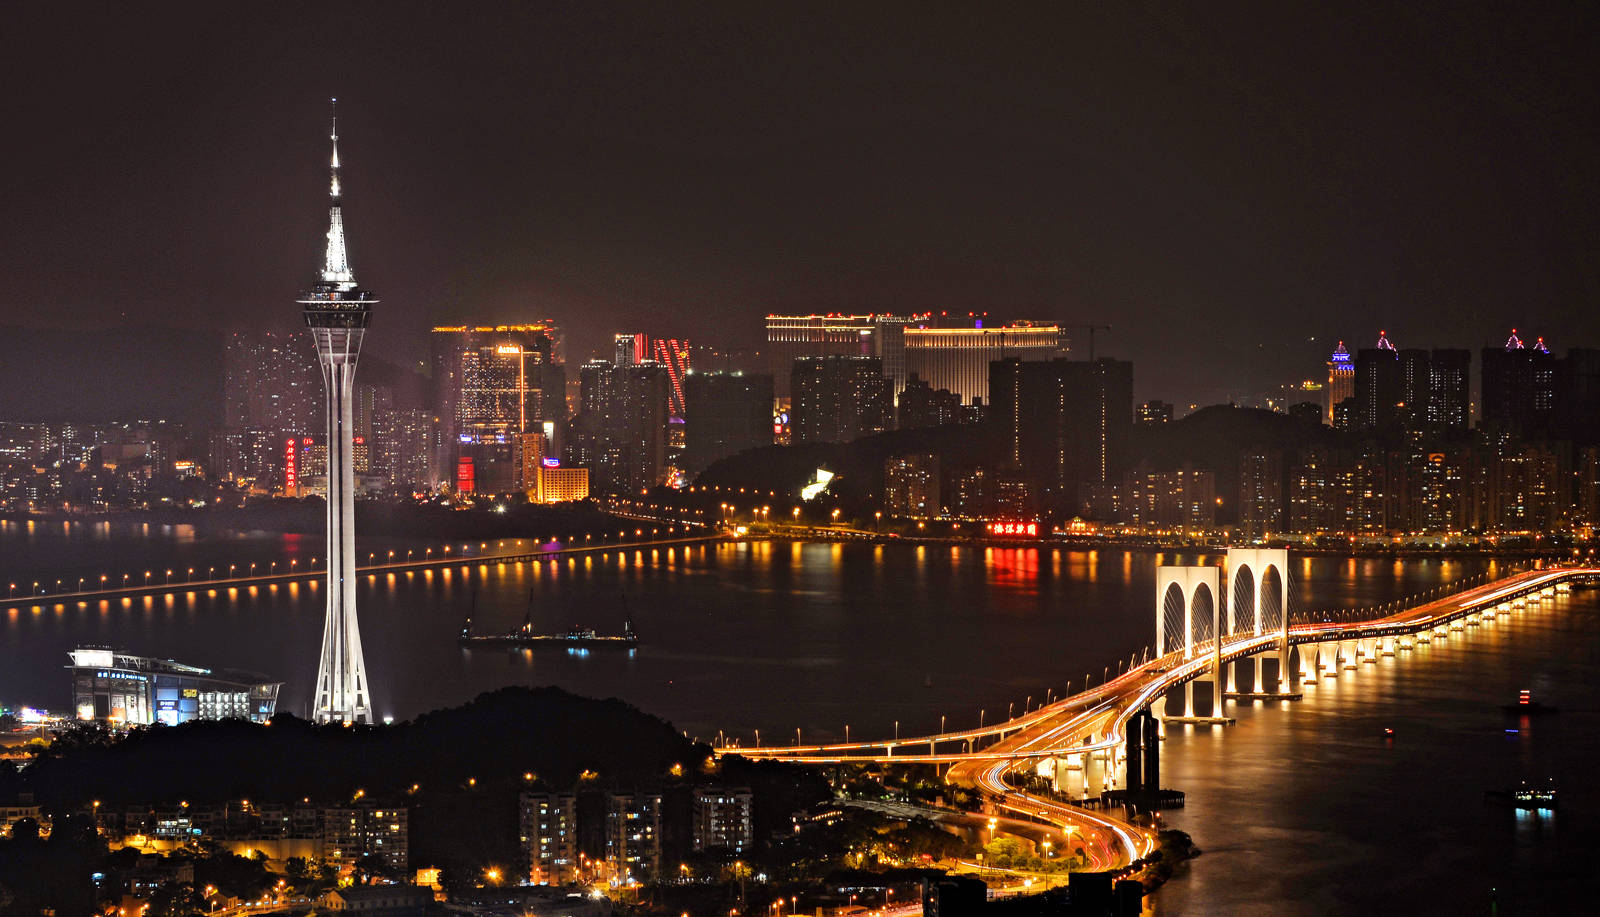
[989,358,1133,515]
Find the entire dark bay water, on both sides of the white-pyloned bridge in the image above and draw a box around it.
[0,523,1600,914]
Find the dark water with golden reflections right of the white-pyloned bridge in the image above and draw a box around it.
[1155,592,1600,915]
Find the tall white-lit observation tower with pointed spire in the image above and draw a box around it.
[299,105,378,723]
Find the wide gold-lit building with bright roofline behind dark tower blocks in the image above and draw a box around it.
[896,318,1067,403]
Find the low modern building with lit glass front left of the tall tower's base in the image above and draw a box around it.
[69,647,283,727]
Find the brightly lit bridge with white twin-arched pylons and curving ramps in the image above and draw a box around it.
[717,549,1600,869]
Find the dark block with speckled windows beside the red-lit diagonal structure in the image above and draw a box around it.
[565,360,667,495]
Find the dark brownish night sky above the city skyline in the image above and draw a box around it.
[0,3,1600,413]
